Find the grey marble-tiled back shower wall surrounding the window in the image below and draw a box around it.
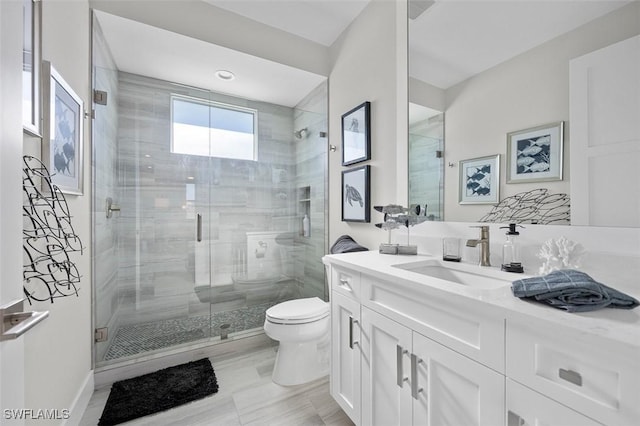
[117,72,324,323]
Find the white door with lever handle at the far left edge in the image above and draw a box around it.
[0,1,27,425]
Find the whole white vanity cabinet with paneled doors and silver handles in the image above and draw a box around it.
[325,253,640,426]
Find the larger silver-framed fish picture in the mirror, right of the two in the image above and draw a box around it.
[507,121,564,183]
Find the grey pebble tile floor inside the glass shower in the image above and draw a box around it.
[104,303,273,361]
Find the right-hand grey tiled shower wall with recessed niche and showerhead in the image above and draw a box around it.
[294,82,328,298]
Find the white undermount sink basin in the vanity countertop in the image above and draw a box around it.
[393,259,521,290]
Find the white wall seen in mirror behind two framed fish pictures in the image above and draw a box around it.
[445,2,640,221]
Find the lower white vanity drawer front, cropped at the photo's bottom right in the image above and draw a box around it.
[507,379,600,426]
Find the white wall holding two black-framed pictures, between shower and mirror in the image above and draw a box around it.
[329,0,408,253]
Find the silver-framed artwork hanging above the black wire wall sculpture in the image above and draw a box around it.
[42,61,84,195]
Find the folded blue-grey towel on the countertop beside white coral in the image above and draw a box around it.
[511,269,640,312]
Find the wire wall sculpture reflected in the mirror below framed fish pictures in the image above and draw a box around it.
[480,188,571,225]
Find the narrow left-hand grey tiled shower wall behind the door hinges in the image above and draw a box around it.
[91,20,118,359]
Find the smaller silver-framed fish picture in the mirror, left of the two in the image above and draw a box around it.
[458,154,500,204]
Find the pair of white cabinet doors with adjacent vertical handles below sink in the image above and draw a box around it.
[361,307,504,426]
